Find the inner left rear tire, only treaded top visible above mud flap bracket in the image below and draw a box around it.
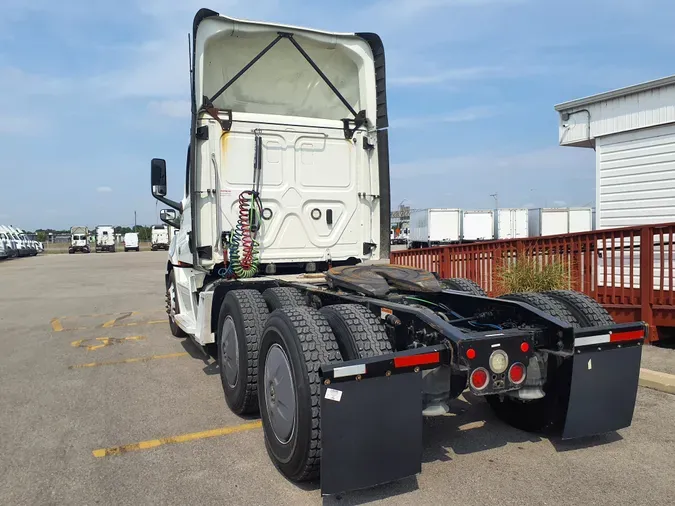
[320,304,392,360]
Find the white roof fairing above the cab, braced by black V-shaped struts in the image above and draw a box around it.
[193,11,378,125]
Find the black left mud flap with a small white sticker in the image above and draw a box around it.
[321,373,423,495]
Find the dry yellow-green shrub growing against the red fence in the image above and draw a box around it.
[497,256,571,293]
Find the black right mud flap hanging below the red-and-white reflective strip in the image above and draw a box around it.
[563,345,642,439]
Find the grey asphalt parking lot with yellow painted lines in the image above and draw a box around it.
[0,252,675,506]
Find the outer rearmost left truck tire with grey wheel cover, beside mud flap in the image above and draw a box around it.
[258,307,342,481]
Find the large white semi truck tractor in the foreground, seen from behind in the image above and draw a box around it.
[151,9,647,494]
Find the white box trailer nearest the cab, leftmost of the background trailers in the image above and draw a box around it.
[408,208,462,248]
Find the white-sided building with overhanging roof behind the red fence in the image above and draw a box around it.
[555,76,675,229]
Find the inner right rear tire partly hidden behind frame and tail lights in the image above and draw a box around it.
[485,292,581,433]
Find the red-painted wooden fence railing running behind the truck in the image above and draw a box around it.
[391,223,675,341]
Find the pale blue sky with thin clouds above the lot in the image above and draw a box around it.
[0,0,675,229]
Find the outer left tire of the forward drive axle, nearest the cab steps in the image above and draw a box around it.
[216,290,269,415]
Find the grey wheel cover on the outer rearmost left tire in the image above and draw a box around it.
[264,344,295,444]
